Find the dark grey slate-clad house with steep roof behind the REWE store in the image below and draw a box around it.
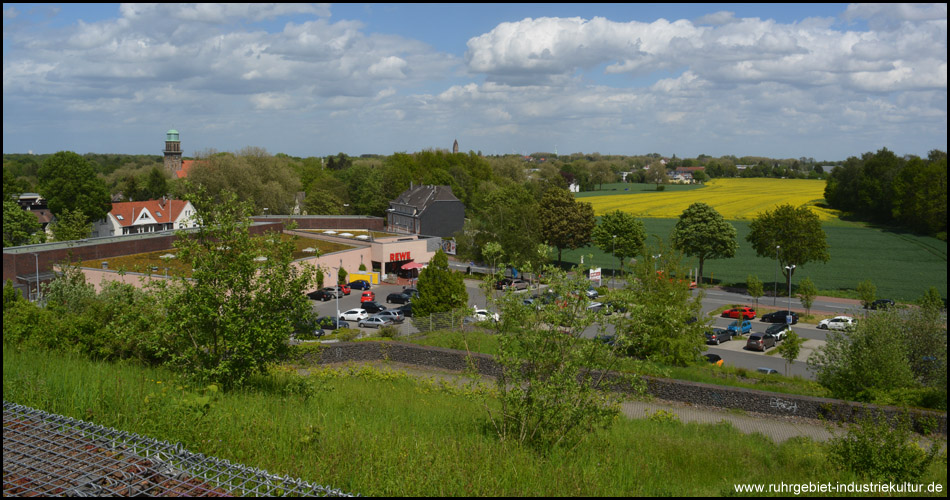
[386,185,465,238]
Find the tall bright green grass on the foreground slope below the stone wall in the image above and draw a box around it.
[3,346,947,497]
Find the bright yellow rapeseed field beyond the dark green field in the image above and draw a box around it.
[579,179,838,220]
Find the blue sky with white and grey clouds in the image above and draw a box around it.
[3,3,947,161]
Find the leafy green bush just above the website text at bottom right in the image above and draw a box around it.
[829,415,938,483]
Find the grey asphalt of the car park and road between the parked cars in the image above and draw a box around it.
[312,276,862,379]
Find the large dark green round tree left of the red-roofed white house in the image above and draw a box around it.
[37,151,112,221]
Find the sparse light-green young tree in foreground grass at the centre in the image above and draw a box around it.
[485,266,642,452]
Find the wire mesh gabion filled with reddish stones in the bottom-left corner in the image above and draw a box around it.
[3,401,353,497]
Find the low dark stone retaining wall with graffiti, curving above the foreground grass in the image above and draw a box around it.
[302,342,947,435]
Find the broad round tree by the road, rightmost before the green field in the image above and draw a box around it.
[746,204,831,296]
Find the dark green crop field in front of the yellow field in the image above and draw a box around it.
[563,179,947,301]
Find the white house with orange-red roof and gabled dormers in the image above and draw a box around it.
[92,198,196,237]
